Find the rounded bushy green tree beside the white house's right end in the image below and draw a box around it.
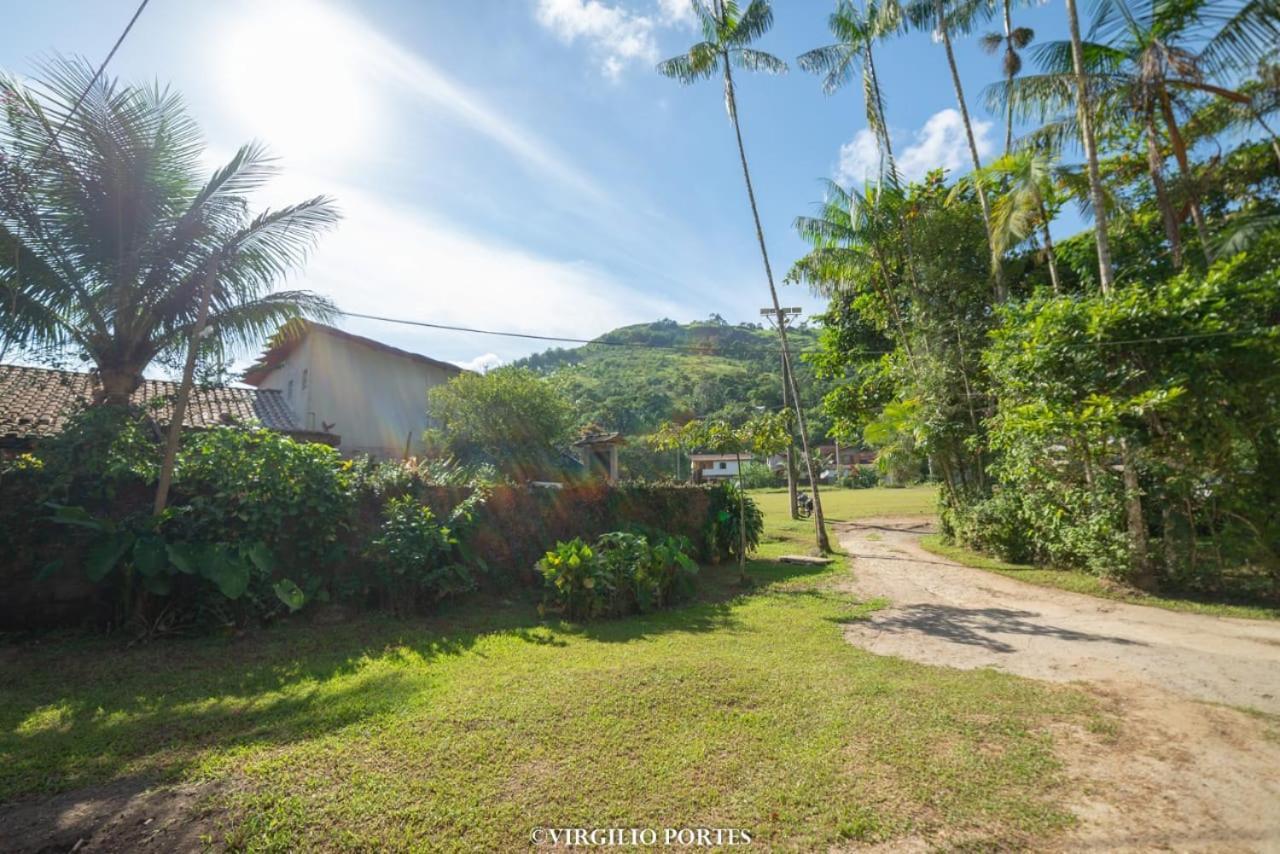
[426,367,573,480]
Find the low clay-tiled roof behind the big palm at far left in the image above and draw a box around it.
[0,365,304,440]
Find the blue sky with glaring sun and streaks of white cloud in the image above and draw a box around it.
[0,0,1080,364]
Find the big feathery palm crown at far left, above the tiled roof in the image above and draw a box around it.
[0,60,338,405]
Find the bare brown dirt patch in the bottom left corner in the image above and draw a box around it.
[0,778,220,854]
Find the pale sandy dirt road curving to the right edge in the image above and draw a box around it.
[840,519,1280,851]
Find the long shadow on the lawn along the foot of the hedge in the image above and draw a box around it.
[0,561,829,803]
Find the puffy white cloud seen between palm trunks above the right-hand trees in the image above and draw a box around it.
[836,108,993,183]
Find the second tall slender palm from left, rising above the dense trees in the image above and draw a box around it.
[796,0,899,183]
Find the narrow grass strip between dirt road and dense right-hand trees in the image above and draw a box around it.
[920,534,1280,620]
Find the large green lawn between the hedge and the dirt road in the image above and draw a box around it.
[0,490,1101,850]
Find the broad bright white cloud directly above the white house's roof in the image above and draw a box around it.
[280,174,680,361]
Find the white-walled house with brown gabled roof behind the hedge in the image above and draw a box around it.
[244,323,462,460]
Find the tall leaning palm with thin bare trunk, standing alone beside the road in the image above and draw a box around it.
[658,0,831,552]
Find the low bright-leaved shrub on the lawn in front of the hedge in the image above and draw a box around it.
[536,531,698,620]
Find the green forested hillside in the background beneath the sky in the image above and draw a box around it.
[517,315,831,439]
